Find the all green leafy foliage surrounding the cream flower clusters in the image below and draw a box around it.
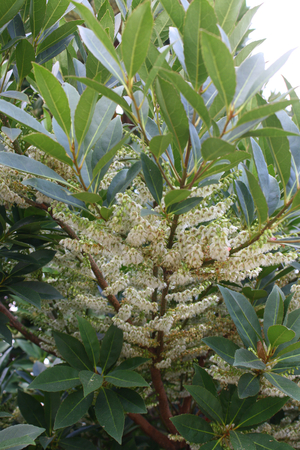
[0,0,300,450]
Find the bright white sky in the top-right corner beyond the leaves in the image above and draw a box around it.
[247,0,300,96]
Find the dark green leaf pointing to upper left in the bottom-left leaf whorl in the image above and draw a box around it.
[53,331,93,370]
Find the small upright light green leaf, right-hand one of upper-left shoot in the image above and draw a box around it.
[74,88,98,148]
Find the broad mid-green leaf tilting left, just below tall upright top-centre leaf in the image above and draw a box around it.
[156,78,189,157]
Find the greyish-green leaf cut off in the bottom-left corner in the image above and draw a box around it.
[0,424,45,450]
